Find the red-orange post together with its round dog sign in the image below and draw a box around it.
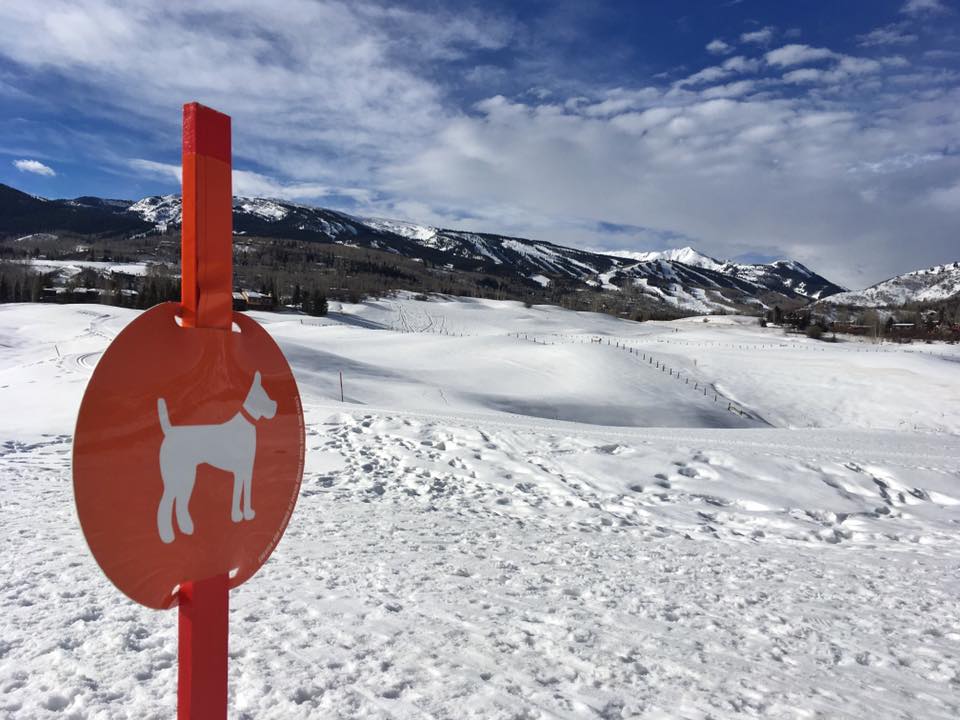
[73,103,305,720]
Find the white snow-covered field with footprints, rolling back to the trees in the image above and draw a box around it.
[0,296,960,720]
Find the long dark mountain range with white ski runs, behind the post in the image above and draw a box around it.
[0,186,843,313]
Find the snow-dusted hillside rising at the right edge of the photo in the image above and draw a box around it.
[823,262,960,308]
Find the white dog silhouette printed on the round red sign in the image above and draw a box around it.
[157,371,277,543]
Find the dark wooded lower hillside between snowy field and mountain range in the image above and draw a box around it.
[0,232,692,320]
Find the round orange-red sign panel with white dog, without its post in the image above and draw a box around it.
[73,303,304,608]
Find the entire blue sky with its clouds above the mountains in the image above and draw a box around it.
[0,0,960,287]
